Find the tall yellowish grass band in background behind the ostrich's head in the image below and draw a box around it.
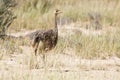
[7,0,120,31]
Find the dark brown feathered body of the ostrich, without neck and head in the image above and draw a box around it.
[32,29,58,55]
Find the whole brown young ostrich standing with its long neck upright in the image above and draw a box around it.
[28,9,61,62]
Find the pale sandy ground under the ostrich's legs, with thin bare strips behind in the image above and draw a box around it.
[0,24,120,80]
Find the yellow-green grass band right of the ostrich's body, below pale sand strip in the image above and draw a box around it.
[55,29,120,59]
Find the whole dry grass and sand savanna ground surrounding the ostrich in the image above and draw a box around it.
[0,0,120,80]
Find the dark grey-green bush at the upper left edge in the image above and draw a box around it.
[0,0,16,35]
